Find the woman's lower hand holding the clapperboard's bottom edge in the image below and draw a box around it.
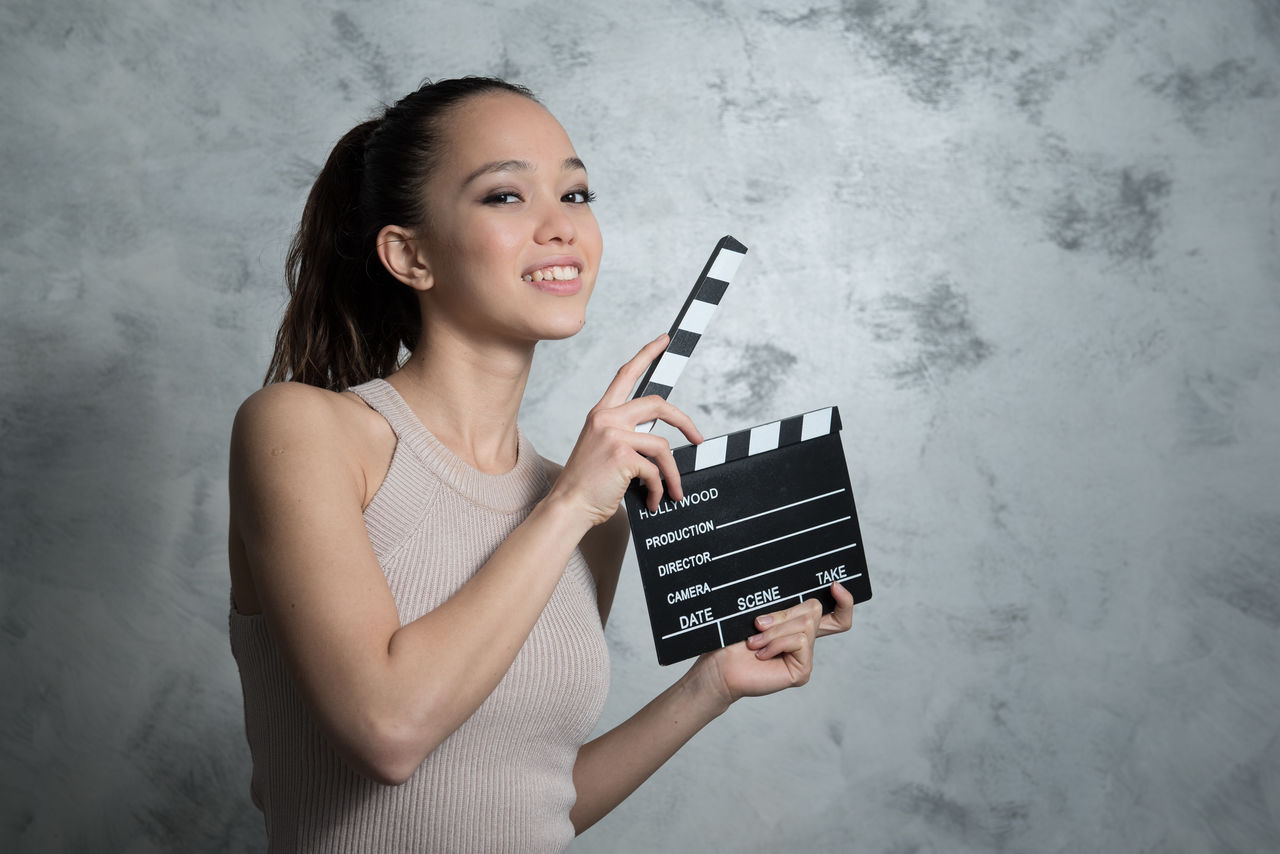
[695,583,854,705]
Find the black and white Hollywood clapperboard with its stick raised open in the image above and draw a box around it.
[626,237,872,665]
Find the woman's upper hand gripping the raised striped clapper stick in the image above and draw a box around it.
[548,334,703,526]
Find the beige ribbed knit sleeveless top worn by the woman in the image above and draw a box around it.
[230,380,609,854]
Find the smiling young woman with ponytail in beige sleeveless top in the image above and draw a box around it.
[229,78,852,853]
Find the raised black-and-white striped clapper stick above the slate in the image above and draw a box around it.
[631,234,746,433]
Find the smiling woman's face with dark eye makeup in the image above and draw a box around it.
[422,92,602,341]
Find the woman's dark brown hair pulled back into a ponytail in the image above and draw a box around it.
[265,77,538,391]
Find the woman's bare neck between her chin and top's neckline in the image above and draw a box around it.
[388,328,534,474]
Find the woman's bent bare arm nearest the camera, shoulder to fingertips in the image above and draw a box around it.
[230,338,700,784]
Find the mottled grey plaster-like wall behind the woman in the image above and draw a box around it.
[0,0,1280,854]
